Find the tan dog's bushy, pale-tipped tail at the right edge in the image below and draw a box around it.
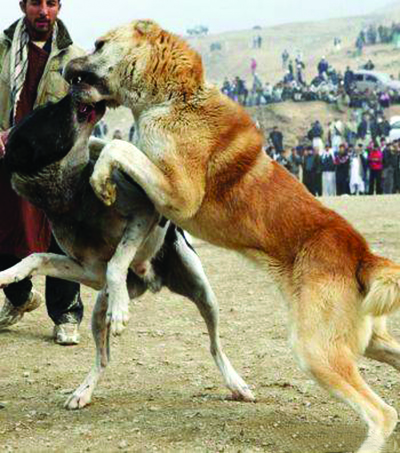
[361,255,400,316]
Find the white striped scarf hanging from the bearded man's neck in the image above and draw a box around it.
[10,18,58,124]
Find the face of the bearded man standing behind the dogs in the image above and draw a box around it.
[20,0,61,40]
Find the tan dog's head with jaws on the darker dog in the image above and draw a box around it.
[64,20,203,108]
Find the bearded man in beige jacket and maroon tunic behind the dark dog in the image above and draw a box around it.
[0,0,84,344]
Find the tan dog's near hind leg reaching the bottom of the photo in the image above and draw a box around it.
[292,282,397,453]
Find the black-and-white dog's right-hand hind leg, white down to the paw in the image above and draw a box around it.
[167,233,255,401]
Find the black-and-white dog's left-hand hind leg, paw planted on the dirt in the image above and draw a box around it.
[65,290,110,409]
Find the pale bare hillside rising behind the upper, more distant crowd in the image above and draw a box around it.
[185,1,400,84]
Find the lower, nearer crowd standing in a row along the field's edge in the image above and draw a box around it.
[266,114,400,196]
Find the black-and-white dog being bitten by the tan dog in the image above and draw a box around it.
[0,96,254,409]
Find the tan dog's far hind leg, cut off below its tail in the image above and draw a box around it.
[365,316,400,371]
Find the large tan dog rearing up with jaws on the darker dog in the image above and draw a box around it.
[66,21,400,453]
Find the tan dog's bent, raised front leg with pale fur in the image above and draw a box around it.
[90,140,204,223]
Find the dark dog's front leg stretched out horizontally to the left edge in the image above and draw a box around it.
[0,253,105,289]
